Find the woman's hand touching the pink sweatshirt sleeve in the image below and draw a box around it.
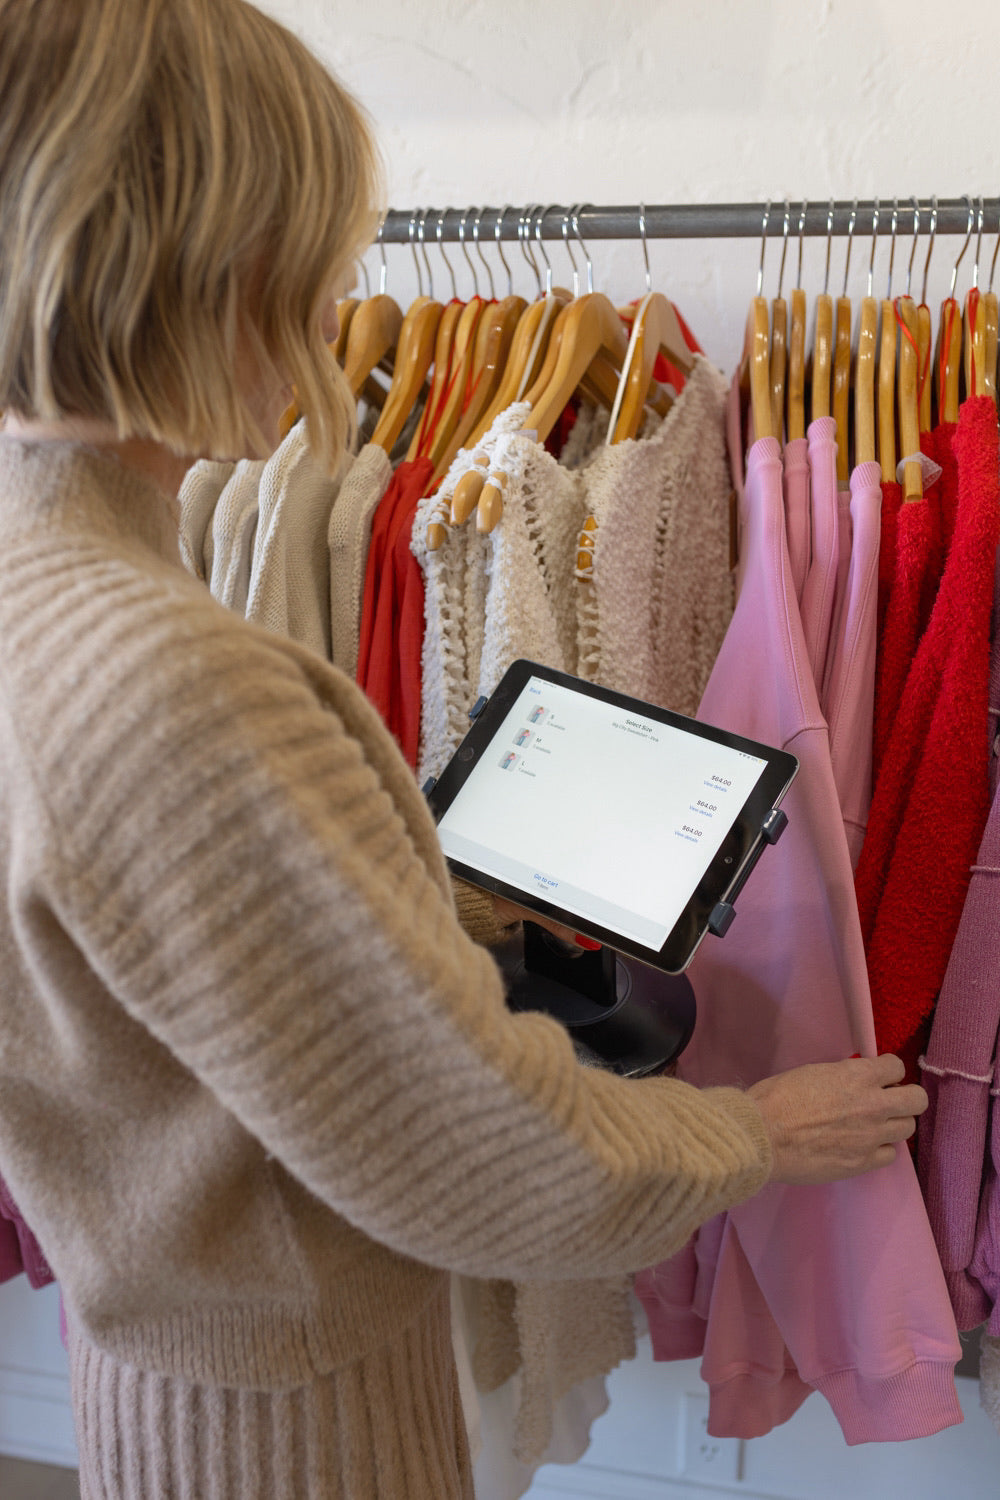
[748,1053,928,1184]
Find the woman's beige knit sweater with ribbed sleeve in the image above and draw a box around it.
[0,440,769,1400]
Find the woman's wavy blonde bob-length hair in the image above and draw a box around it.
[0,0,381,465]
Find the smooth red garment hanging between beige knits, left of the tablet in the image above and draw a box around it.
[357,458,433,770]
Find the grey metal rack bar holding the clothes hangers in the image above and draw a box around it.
[382,197,1000,245]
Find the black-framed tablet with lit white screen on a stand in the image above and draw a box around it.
[424,662,798,974]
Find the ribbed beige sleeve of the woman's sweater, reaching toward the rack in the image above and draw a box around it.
[3,444,769,1302]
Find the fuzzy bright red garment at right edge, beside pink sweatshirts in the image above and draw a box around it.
[856,396,1000,1050]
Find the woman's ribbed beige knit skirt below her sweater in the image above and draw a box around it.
[69,1278,472,1500]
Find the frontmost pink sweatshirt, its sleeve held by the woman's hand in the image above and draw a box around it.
[637,438,961,1443]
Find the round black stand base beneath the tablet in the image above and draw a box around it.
[495,923,696,1077]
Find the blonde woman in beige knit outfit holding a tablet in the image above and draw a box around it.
[0,0,924,1500]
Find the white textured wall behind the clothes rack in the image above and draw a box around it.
[254,0,1000,366]
